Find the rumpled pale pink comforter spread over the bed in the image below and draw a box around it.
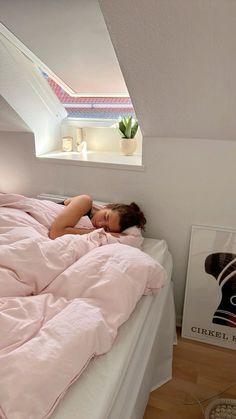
[0,194,165,419]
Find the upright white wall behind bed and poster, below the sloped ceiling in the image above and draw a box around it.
[0,132,236,324]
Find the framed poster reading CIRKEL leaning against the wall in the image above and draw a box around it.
[182,225,236,349]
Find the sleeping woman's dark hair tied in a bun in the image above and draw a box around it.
[106,202,146,231]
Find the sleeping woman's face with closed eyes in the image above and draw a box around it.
[91,208,120,233]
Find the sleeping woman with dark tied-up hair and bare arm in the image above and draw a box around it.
[49,195,146,239]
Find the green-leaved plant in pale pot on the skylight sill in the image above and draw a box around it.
[118,115,139,156]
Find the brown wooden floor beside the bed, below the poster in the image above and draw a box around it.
[143,330,236,419]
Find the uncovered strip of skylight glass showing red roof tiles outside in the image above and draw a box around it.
[43,73,135,120]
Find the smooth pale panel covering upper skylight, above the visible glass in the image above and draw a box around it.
[0,0,128,96]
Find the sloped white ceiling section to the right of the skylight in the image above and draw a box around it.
[99,0,236,140]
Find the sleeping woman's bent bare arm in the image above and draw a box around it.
[49,195,93,239]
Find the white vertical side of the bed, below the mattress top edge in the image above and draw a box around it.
[106,258,175,419]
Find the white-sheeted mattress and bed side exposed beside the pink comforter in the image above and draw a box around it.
[51,239,175,419]
